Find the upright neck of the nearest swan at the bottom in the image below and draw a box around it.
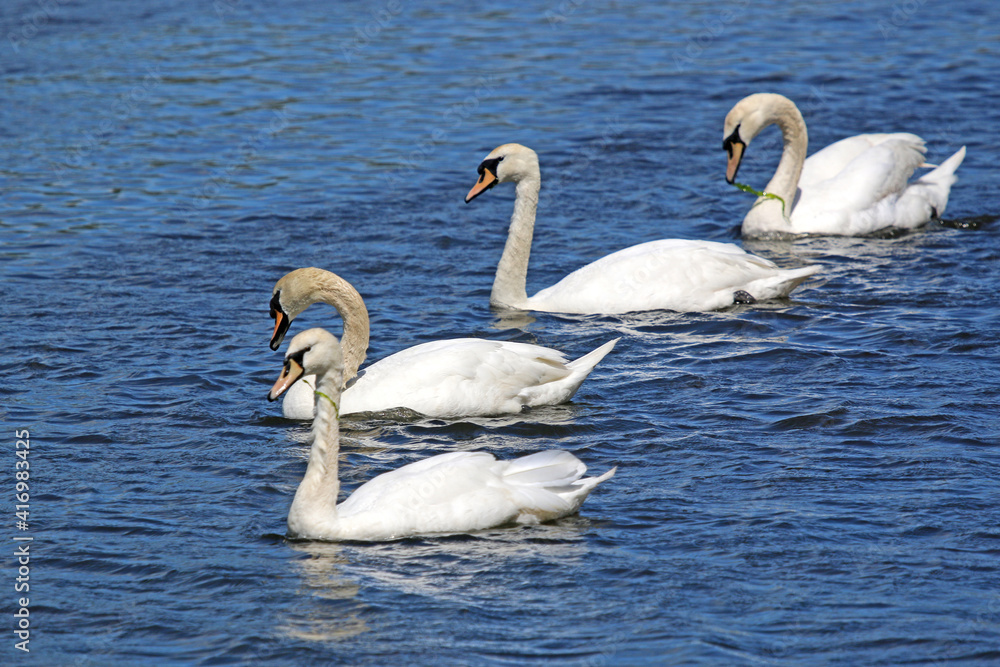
[288,375,340,536]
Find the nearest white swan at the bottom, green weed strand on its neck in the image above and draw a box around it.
[267,329,615,541]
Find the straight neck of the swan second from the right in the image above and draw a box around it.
[490,174,542,308]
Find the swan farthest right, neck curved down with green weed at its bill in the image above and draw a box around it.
[722,93,965,237]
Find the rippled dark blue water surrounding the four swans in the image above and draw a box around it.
[0,0,1000,665]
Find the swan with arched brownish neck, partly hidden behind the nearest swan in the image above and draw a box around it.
[270,267,619,419]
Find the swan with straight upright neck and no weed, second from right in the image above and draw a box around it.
[465,144,819,314]
